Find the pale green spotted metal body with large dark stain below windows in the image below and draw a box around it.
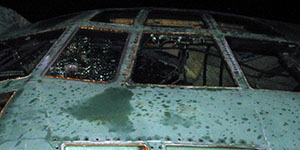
[0,8,300,149]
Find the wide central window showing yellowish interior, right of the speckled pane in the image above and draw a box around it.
[132,34,236,87]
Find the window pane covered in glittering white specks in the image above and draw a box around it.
[46,29,128,82]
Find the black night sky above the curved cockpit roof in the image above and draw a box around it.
[0,0,300,24]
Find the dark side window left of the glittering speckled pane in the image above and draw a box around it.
[0,30,63,80]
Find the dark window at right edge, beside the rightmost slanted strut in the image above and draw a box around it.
[226,38,300,92]
